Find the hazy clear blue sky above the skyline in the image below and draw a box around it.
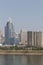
[0,0,43,33]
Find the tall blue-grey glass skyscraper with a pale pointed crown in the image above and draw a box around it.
[5,18,14,45]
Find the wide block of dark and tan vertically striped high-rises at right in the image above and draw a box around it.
[27,31,43,47]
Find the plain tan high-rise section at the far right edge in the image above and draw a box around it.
[36,31,43,47]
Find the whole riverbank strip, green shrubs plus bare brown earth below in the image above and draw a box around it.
[0,46,43,55]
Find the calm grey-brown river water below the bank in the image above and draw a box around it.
[0,55,43,65]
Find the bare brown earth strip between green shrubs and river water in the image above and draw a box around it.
[0,50,43,55]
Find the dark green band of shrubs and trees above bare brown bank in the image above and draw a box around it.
[0,46,43,51]
